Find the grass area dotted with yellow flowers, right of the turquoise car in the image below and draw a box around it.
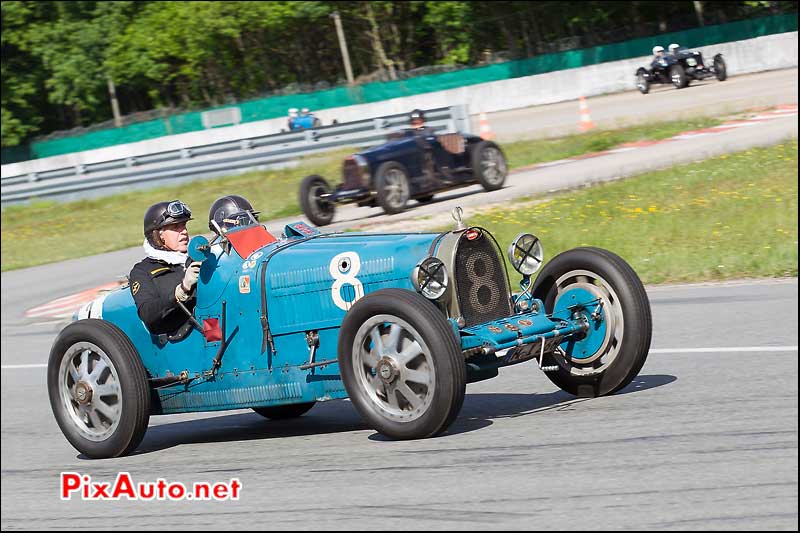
[460,140,798,283]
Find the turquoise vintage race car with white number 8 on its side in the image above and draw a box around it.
[47,209,652,458]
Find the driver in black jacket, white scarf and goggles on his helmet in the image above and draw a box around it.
[128,200,200,334]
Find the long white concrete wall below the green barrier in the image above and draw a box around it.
[2,32,798,177]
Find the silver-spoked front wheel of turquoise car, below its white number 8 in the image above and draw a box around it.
[338,289,466,439]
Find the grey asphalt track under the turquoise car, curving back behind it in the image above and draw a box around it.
[0,69,798,530]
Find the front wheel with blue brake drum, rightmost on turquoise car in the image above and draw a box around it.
[533,247,653,396]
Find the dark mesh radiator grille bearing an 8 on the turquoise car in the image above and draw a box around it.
[455,233,512,326]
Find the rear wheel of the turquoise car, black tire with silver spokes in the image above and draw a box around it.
[47,319,150,459]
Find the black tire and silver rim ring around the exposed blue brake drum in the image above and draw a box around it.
[533,248,653,396]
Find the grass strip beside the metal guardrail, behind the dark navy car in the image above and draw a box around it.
[0,114,752,271]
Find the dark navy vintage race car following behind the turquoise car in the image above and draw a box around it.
[300,128,508,226]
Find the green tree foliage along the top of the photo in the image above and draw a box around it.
[2,0,797,146]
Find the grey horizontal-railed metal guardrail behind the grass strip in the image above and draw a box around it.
[0,105,471,205]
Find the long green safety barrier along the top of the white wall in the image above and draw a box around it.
[3,13,797,164]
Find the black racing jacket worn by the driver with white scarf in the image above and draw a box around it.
[128,257,197,335]
